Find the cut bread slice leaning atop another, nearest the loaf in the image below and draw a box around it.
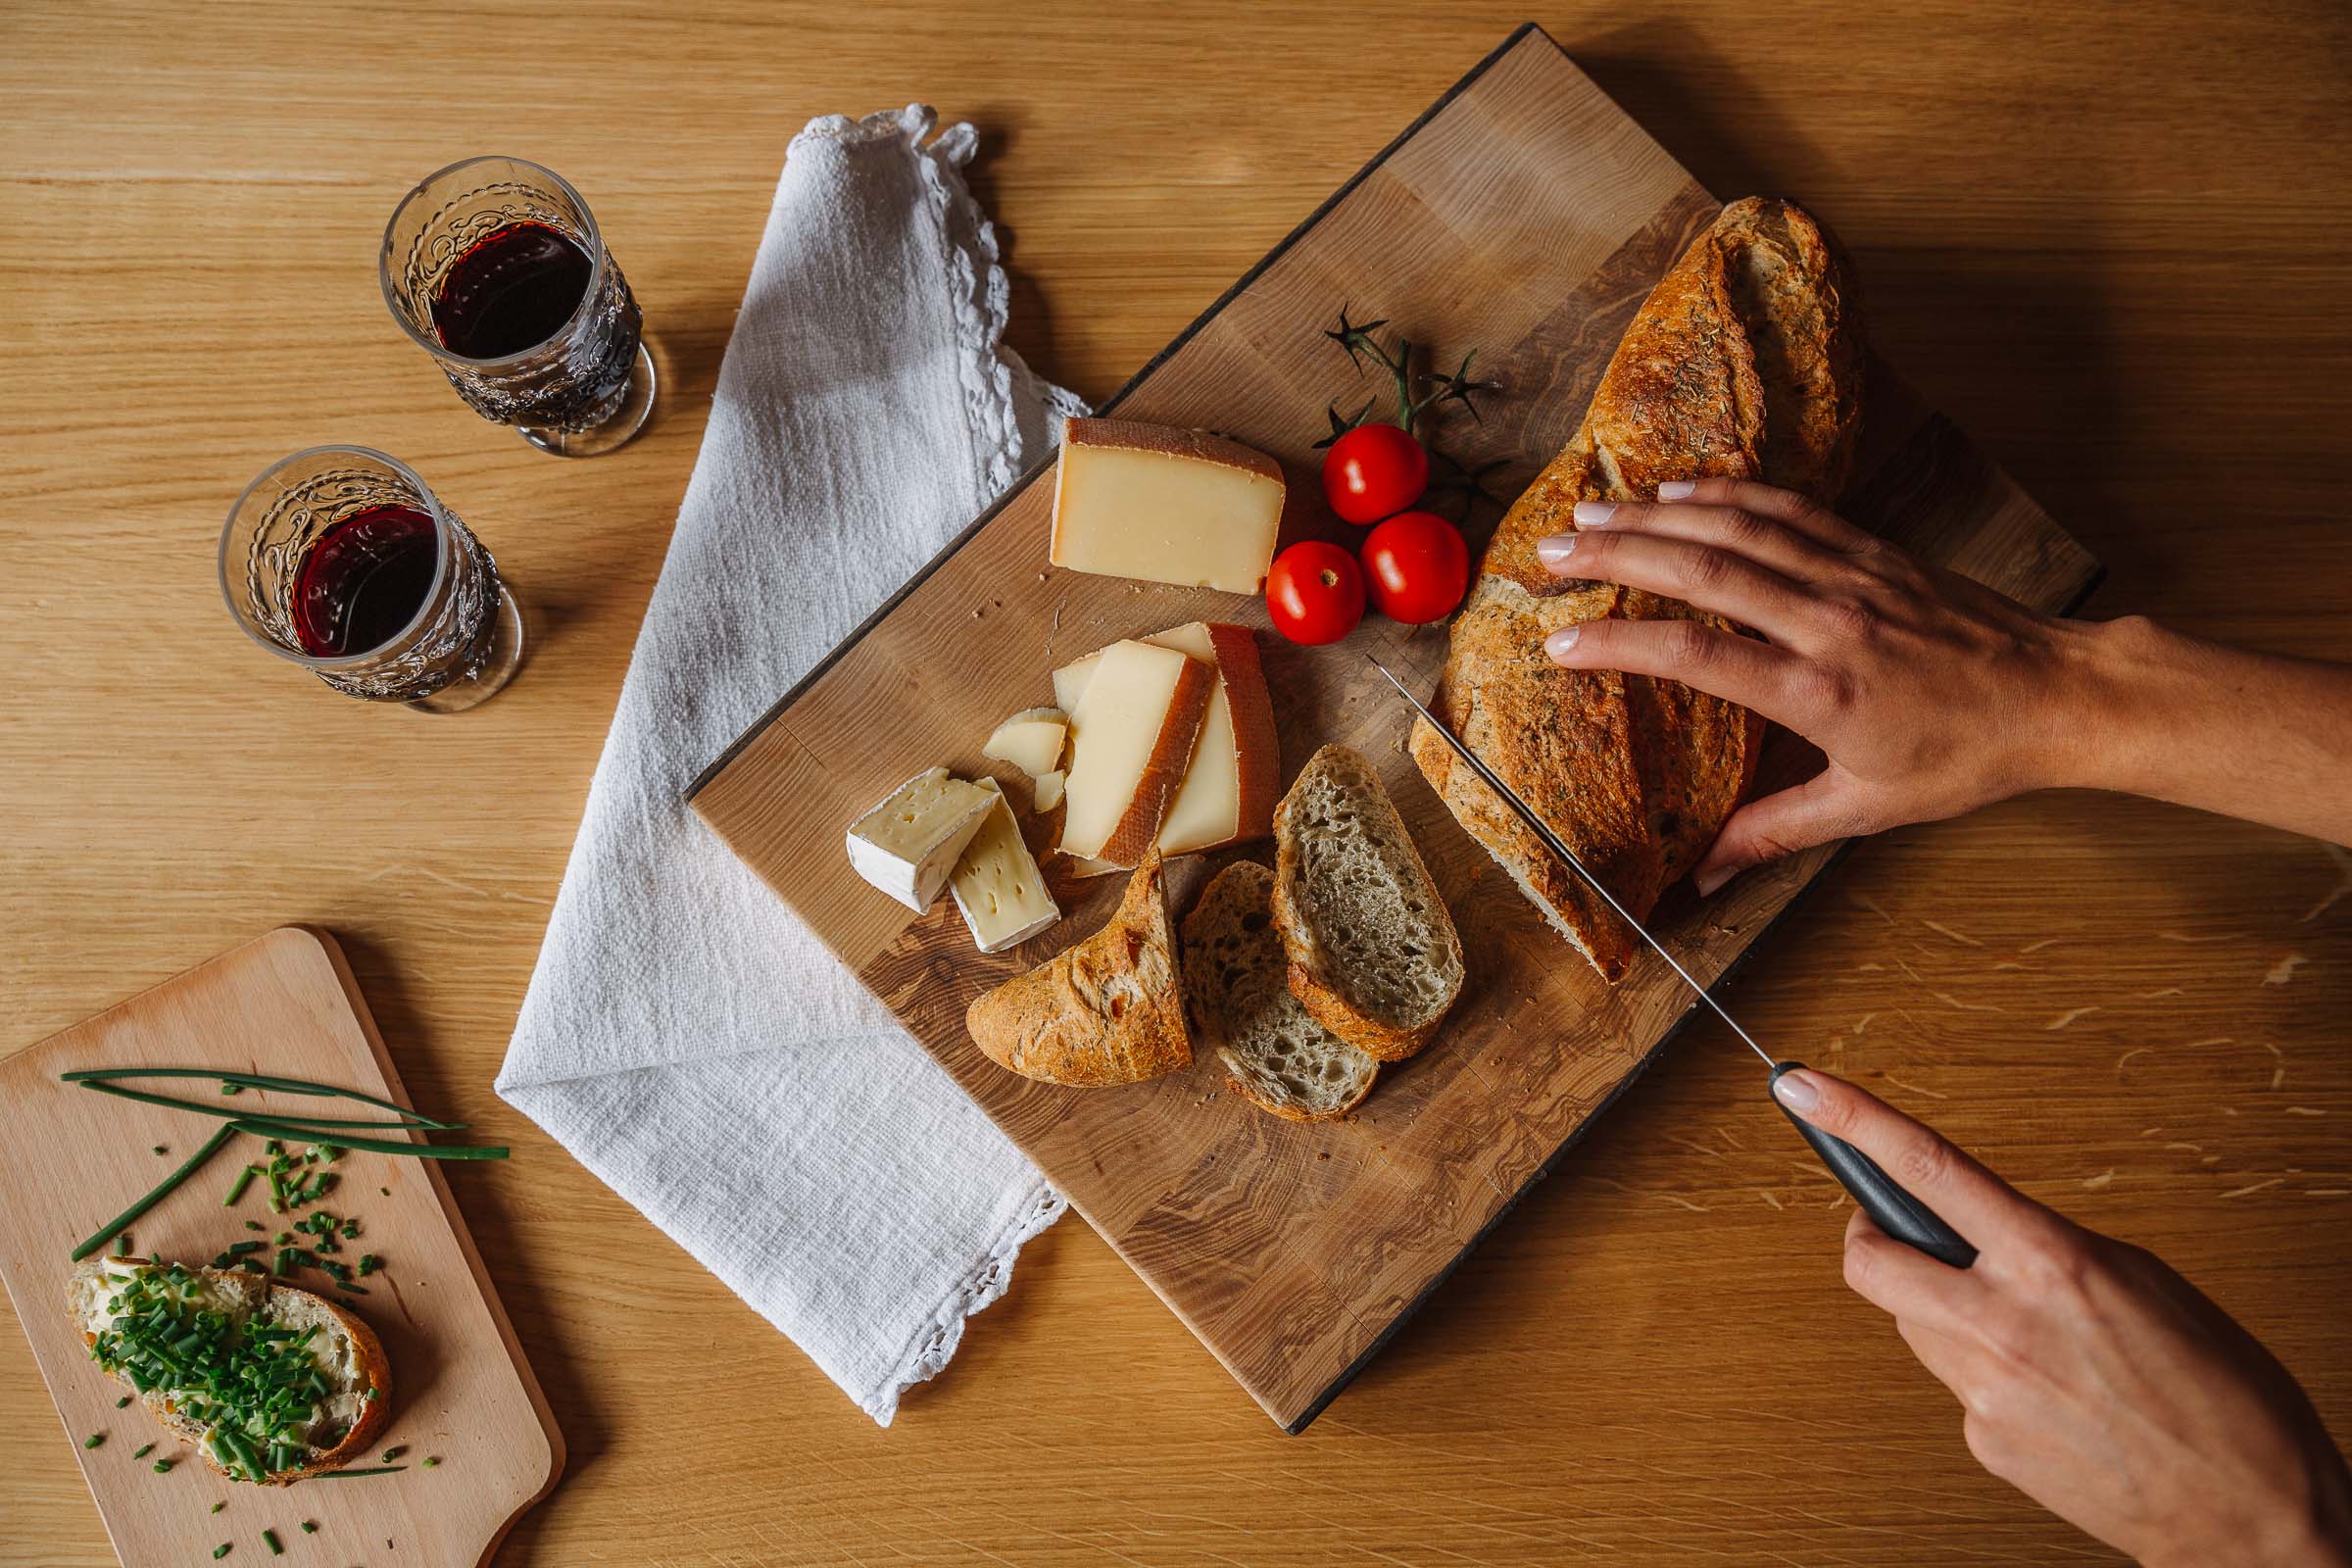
[1272,745,1463,1062]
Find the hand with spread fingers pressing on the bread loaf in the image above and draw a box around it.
[1536,479,2100,894]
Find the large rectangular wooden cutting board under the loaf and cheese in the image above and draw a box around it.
[694,28,2095,1432]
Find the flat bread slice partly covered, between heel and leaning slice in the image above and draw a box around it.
[1183,860,1381,1121]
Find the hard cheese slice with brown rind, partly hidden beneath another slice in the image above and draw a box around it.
[1054,620,1282,856]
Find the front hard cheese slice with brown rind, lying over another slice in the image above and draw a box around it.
[1060,642,1216,865]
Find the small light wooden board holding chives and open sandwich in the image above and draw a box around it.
[0,926,564,1568]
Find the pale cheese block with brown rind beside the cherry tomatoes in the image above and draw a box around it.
[1052,418,1282,592]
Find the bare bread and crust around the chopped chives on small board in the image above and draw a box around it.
[66,1257,393,1486]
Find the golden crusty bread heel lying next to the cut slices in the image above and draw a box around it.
[964,849,1193,1089]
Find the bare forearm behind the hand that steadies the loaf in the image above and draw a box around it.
[2048,615,2352,844]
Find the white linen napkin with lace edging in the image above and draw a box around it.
[499,104,1080,1425]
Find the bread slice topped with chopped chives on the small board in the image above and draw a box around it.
[66,1257,393,1486]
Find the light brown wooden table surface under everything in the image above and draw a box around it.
[0,0,2352,1568]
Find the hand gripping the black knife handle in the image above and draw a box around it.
[1774,1069,2352,1568]
